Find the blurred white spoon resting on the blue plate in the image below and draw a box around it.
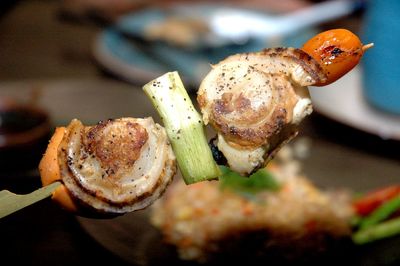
[208,0,360,47]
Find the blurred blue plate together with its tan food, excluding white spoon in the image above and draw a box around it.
[93,4,316,89]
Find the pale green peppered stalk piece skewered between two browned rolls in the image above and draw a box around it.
[143,72,221,184]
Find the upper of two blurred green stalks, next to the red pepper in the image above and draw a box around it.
[360,197,400,229]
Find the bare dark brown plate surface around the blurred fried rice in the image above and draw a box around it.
[78,136,400,265]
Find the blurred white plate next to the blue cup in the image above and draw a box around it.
[310,68,400,140]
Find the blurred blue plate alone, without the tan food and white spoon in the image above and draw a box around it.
[94,5,316,88]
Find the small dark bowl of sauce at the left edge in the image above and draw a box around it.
[0,98,51,173]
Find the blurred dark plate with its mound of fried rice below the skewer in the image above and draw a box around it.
[78,139,400,265]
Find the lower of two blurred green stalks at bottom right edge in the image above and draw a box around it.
[353,218,400,245]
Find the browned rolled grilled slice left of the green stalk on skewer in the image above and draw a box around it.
[54,118,176,214]
